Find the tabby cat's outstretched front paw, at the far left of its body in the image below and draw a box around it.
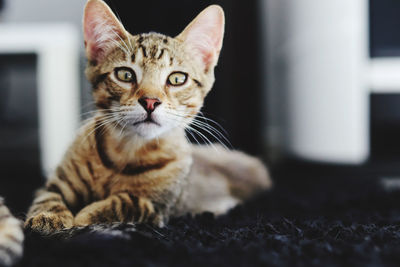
[24,212,73,234]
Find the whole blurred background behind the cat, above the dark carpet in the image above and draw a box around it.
[0,0,400,212]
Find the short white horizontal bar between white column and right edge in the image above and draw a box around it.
[369,57,400,93]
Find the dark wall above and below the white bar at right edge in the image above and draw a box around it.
[369,0,400,162]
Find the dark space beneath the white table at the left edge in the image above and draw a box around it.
[0,54,43,215]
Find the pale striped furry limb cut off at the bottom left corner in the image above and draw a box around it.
[0,198,24,266]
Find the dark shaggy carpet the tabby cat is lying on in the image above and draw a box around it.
[19,162,400,266]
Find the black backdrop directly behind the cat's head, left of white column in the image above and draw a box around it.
[106,0,262,154]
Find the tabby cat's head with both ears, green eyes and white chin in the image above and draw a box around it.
[84,0,224,139]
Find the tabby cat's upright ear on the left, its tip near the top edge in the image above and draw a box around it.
[83,0,127,62]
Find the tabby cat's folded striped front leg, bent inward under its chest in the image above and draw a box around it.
[74,192,165,227]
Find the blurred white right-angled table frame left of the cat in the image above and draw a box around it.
[0,23,80,175]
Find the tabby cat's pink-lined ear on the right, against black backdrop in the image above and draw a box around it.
[176,5,225,69]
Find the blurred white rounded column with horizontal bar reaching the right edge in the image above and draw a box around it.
[262,0,400,164]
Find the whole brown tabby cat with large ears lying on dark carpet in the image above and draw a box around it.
[25,0,271,233]
